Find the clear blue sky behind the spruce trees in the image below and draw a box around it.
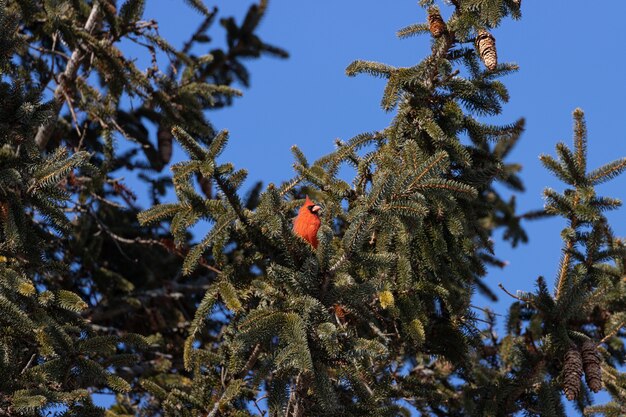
[98,0,626,410]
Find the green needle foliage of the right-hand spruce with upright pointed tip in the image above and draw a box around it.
[464,109,626,416]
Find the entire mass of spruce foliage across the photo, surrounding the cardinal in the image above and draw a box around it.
[0,0,626,417]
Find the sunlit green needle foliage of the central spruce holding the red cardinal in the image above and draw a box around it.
[134,0,544,416]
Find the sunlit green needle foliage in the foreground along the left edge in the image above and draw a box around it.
[0,3,148,416]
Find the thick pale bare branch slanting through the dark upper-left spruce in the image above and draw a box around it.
[35,1,100,149]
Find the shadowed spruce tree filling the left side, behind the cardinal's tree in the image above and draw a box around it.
[0,0,287,416]
